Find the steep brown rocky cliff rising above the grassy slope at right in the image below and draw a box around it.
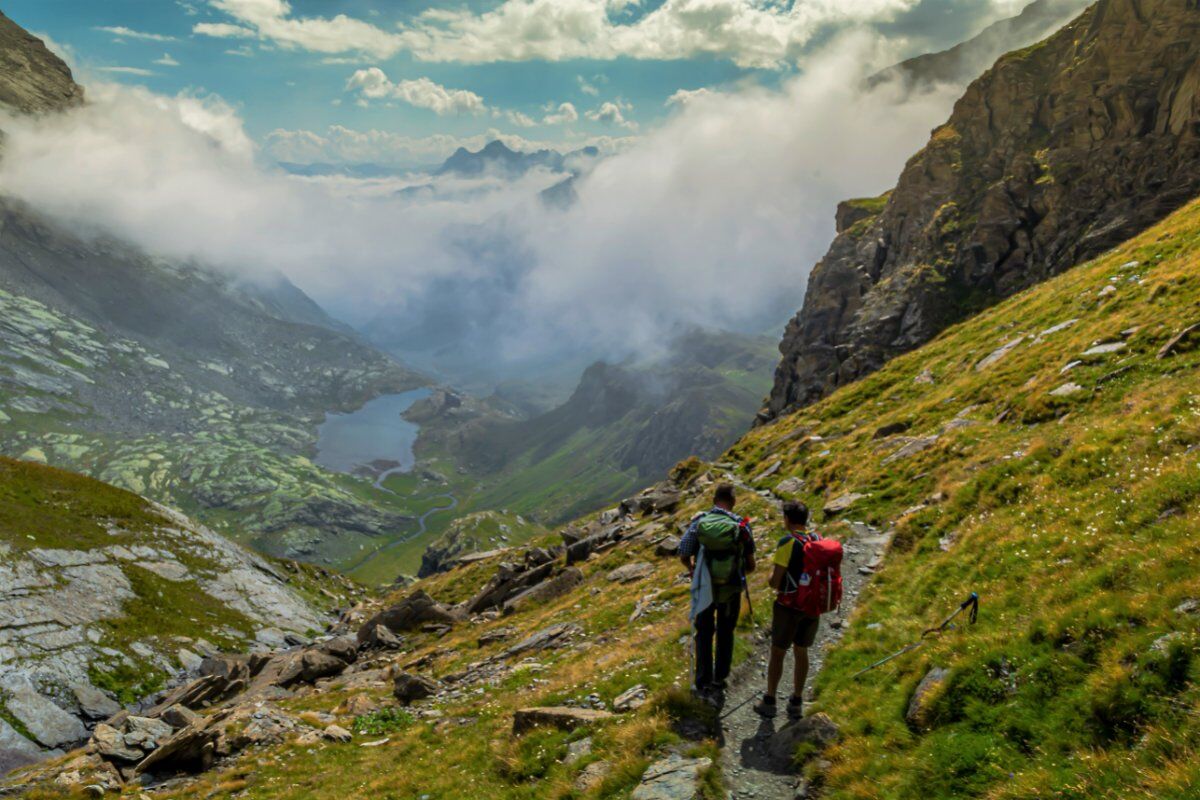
[761,0,1200,420]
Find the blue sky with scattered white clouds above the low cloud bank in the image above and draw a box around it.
[4,0,1021,162]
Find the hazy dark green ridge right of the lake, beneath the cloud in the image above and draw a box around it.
[414,331,770,522]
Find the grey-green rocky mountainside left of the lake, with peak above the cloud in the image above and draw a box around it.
[0,18,425,563]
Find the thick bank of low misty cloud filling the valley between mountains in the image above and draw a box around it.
[0,17,1070,376]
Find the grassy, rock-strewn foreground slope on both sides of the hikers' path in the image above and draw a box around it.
[13,195,1200,800]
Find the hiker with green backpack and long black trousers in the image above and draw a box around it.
[679,483,755,703]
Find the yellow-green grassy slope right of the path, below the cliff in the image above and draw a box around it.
[715,196,1200,798]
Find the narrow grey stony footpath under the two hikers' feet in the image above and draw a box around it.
[721,524,889,800]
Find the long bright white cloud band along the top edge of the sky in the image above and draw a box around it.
[193,0,926,68]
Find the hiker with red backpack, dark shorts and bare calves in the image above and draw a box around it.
[754,503,842,720]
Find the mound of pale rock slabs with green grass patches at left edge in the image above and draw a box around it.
[0,458,355,771]
